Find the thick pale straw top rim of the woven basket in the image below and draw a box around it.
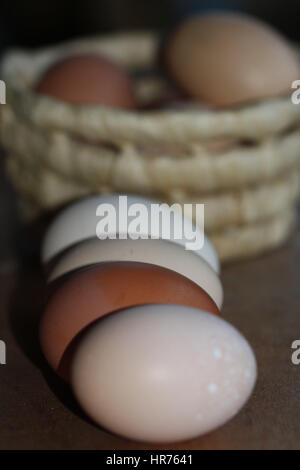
[1,32,300,144]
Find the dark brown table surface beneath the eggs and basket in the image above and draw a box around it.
[0,160,300,450]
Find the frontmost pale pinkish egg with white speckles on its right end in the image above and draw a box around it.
[71,304,256,443]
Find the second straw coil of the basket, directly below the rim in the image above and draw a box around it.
[0,105,300,194]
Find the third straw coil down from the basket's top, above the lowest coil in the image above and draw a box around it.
[7,154,300,232]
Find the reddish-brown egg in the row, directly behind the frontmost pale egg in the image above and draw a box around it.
[40,262,219,379]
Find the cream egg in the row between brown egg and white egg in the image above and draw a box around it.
[49,238,223,308]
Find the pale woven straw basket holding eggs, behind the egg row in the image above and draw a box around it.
[0,33,300,260]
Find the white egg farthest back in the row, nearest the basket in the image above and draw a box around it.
[42,194,220,273]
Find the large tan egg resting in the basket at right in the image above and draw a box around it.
[165,13,300,107]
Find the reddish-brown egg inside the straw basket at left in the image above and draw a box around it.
[35,54,136,109]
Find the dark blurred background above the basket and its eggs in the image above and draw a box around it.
[0,0,300,50]
